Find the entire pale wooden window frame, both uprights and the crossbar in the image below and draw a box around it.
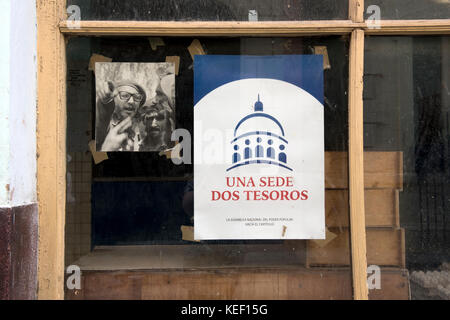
[37,0,450,300]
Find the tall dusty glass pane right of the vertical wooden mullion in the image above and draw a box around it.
[364,37,450,299]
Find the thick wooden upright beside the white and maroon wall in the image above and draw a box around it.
[36,0,66,300]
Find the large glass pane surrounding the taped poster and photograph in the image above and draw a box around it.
[66,36,352,299]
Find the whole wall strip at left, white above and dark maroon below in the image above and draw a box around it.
[0,0,38,299]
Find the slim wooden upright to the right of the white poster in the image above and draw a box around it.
[348,29,368,300]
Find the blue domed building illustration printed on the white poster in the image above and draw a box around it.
[227,95,292,171]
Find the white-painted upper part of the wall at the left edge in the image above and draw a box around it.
[0,0,36,207]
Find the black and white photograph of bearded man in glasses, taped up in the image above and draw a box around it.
[95,62,175,152]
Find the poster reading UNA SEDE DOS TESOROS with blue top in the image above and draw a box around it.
[194,55,325,240]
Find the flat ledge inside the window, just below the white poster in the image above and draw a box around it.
[73,241,306,271]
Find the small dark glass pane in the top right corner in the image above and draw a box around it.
[365,0,450,20]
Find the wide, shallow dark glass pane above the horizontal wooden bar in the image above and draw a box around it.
[68,0,348,21]
